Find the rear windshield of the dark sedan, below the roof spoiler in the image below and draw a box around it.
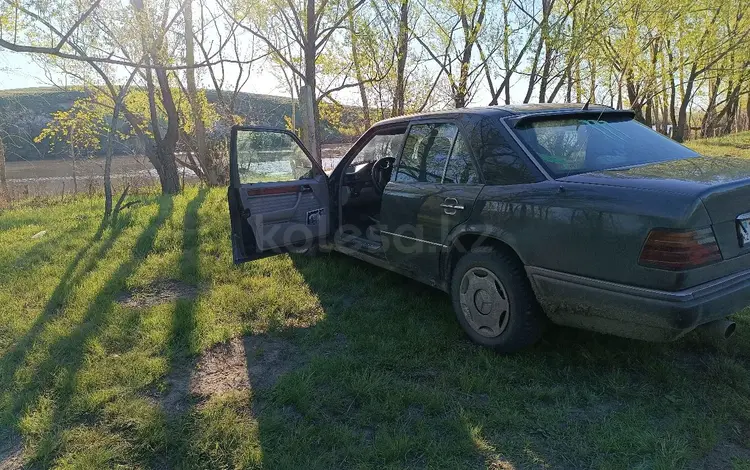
[515,117,698,177]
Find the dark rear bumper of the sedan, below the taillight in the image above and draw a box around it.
[526,266,750,341]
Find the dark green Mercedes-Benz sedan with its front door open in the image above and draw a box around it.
[229,105,750,352]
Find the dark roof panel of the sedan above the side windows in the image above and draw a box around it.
[378,103,612,125]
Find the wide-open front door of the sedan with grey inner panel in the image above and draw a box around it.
[228,126,330,264]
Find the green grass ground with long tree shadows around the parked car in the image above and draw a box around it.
[0,135,750,470]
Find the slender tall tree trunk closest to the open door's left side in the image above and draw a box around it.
[183,0,219,186]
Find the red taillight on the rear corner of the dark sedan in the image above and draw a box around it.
[638,227,721,270]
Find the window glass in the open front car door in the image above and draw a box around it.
[237,129,317,184]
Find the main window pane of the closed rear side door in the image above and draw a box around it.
[395,124,458,183]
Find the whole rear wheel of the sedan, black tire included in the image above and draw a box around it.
[451,247,548,353]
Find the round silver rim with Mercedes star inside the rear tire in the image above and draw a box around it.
[459,267,510,338]
